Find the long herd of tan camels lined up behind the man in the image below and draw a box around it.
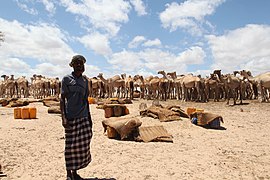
[0,70,270,104]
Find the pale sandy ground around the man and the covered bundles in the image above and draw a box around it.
[0,100,270,180]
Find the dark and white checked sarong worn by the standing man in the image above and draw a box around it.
[65,117,92,170]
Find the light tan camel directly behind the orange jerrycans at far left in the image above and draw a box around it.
[15,76,29,98]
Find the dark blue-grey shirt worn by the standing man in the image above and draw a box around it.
[61,73,89,120]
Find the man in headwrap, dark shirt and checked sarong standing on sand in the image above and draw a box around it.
[60,55,92,180]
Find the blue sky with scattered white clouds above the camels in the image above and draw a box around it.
[0,0,270,78]
